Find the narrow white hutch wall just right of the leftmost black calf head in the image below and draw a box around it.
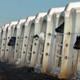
[10,19,26,64]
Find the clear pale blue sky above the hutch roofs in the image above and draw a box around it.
[0,0,80,26]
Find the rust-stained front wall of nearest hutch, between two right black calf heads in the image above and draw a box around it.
[59,9,80,78]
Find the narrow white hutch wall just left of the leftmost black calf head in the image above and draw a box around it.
[4,21,17,62]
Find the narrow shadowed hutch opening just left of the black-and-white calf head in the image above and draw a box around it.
[25,17,35,66]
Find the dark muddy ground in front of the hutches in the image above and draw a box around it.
[0,62,58,80]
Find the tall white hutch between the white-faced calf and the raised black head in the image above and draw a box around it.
[41,8,64,72]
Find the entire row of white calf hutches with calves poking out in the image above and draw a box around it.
[0,2,80,79]
